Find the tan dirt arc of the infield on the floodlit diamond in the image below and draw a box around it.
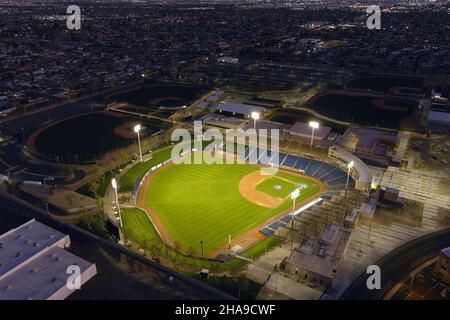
[239,171,284,209]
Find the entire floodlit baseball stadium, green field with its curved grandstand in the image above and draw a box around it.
[129,132,372,259]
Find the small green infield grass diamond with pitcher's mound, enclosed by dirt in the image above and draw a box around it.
[256,172,320,199]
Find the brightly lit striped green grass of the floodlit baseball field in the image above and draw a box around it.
[139,164,319,255]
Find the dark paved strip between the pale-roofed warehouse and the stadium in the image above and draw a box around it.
[0,195,233,300]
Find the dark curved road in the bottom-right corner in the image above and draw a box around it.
[340,228,450,300]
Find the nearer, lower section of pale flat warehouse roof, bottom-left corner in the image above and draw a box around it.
[0,247,96,300]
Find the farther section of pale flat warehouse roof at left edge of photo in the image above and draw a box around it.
[0,219,70,279]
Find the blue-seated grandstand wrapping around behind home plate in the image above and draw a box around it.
[229,147,364,240]
